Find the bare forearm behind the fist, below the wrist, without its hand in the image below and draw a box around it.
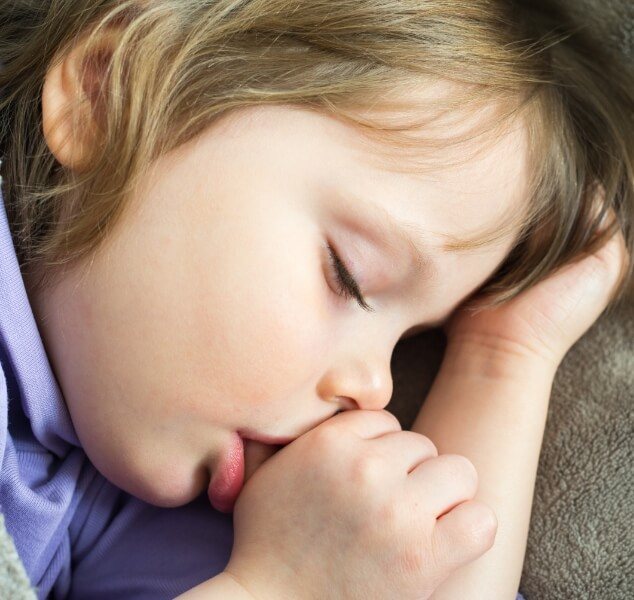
[412,344,555,600]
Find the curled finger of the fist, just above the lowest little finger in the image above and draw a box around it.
[408,454,478,518]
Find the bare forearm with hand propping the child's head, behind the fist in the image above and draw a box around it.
[413,227,629,600]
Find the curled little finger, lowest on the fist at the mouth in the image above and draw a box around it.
[432,500,498,572]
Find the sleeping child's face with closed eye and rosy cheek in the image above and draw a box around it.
[27,107,526,506]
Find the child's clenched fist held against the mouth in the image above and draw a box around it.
[225,410,497,600]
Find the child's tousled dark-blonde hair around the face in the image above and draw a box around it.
[0,0,634,302]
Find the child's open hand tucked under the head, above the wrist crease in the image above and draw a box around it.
[446,233,629,366]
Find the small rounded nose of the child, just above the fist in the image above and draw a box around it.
[317,357,393,410]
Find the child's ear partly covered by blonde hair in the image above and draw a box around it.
[42,30,119,171]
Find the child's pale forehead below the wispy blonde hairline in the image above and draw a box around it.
[209,94,529,249]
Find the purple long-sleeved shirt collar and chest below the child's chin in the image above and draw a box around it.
[0,190,233,600]
